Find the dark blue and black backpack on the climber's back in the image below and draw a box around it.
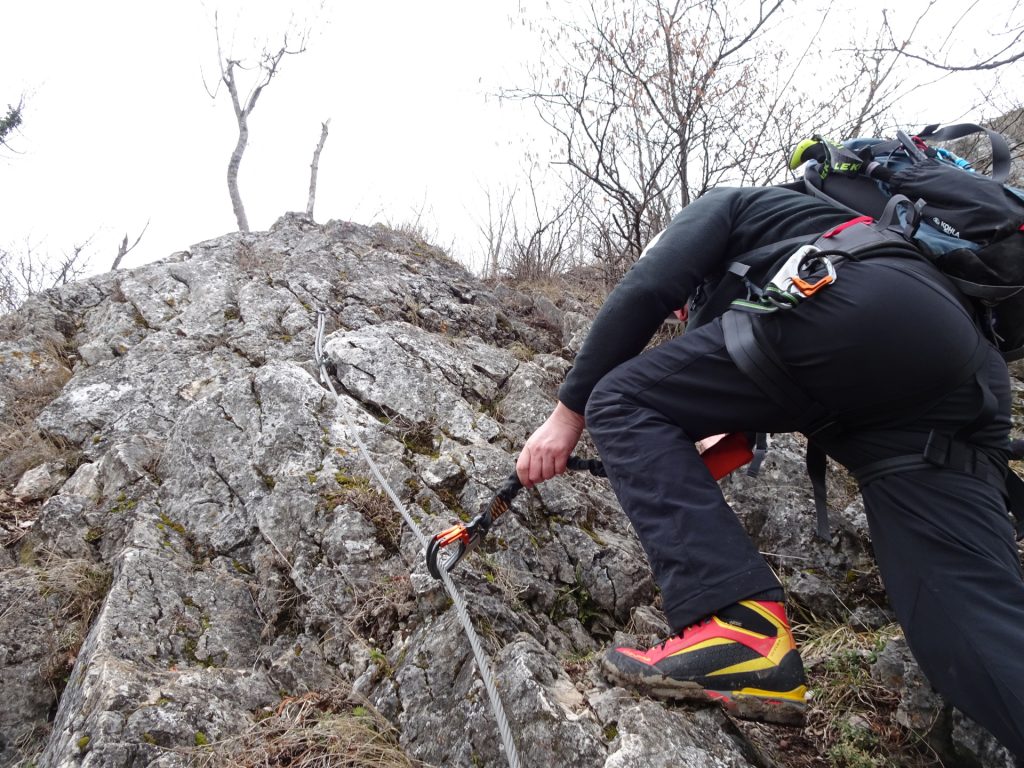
[786,123,1024,361]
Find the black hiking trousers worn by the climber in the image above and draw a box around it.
[586,261,1024,755]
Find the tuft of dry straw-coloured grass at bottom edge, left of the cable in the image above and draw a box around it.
[185,688,424,768]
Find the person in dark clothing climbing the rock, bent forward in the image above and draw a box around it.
[516,187,1024,756]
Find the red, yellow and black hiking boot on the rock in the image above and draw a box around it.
[603,600,807,725]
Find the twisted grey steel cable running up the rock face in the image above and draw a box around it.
[313,308,522,768]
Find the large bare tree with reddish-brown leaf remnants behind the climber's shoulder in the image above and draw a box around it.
[505,0,827,270]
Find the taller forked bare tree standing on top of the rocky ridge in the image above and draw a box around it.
[207,14,308,232]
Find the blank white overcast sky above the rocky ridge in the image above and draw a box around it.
[0,0,1019,280]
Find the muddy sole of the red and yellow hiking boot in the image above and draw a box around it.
[602,663,807,726]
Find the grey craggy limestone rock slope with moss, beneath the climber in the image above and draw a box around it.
[0,214,1010,768]
